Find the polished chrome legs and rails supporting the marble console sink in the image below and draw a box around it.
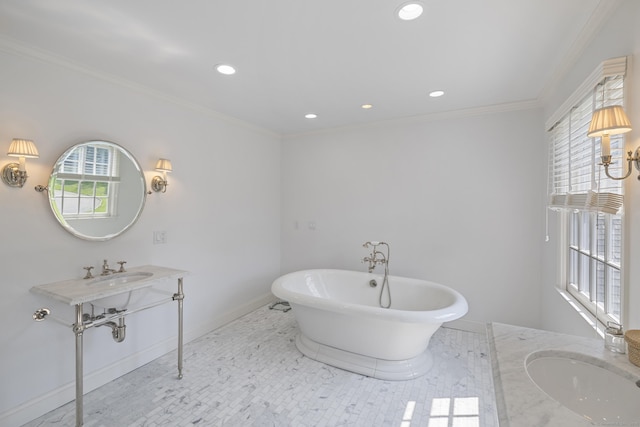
[51,277,184,427]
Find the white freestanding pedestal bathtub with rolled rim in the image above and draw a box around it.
[271,269,468,380]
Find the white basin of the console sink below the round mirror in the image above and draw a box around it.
[85,271,153,311]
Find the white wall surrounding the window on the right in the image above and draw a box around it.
[541,0,640,336]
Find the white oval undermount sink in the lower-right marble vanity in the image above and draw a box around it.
[525,350,640,425]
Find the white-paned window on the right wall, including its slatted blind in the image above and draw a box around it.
[547,58,626,324]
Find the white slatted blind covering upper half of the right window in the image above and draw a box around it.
[549,61,626,214]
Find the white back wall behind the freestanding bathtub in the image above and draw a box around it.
[282,110,546,327]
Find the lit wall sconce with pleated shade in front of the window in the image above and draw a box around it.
[587,105,640,180]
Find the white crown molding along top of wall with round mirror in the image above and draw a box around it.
[0,35,281,138]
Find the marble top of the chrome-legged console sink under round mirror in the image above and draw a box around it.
[31,265,187,305]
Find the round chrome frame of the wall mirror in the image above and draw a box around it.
[43,139,148,242]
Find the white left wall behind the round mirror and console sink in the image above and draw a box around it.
[0,49,281,425]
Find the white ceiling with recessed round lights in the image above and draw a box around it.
[0,0,610,135]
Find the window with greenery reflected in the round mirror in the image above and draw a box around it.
[53,143,120,218]
